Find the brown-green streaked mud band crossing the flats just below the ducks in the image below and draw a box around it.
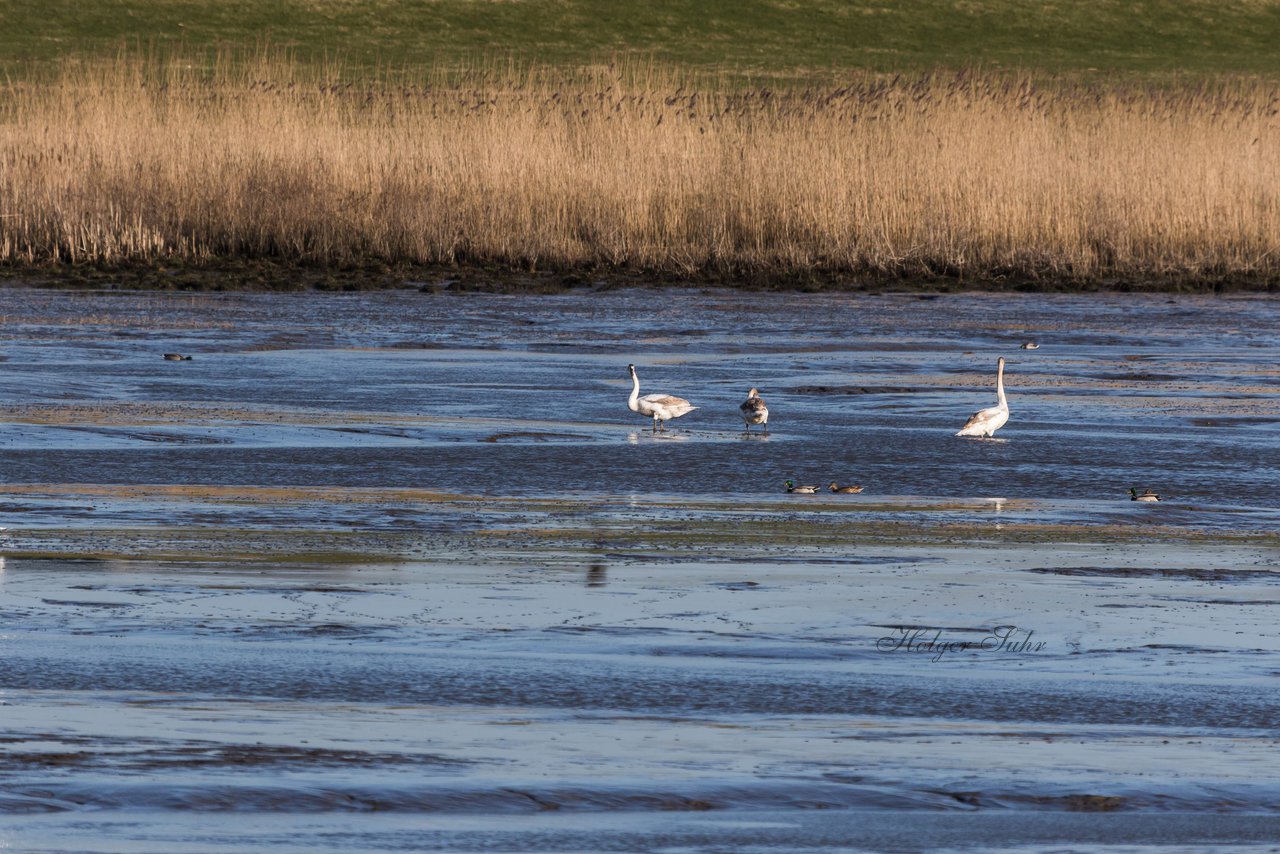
[8,486,1280,566]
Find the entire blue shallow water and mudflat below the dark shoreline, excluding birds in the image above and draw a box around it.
[0,289,1280,851]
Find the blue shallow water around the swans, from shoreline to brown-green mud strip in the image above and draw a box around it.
[0,291,1280,508]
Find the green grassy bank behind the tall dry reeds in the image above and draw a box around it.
[0,0,1280,77]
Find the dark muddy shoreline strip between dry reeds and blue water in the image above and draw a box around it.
[0,259,1280,294]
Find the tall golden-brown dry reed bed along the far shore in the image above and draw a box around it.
[0,59,1280,280]
